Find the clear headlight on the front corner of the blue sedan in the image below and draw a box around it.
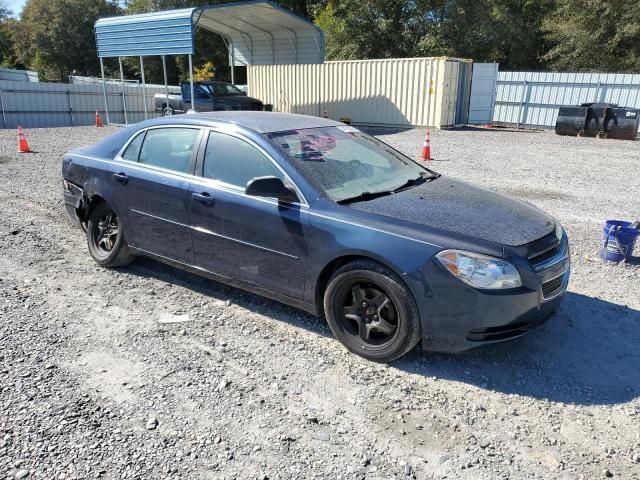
[436,250,522,289]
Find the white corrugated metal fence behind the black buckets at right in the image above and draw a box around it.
[493,72,640,127]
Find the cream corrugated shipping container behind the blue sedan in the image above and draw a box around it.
[247,57,469,127]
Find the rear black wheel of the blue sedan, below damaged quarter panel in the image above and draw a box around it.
[87,202,135,268]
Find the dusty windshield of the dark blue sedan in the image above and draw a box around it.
[267,125,437,202]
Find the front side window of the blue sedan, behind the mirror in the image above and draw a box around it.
[203,132,284,189]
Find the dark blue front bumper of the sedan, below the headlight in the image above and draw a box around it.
[412,236,570,352]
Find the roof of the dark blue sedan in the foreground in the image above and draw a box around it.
[143,111,344,133]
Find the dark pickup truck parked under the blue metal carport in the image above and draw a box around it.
[154,80,271,117]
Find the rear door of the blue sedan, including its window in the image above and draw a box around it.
[113,126,201,265]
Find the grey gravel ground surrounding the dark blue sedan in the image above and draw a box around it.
[0,127,640,480]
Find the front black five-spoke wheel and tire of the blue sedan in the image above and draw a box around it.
[324,260,422,362]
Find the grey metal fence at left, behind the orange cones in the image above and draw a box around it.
[0,81,180,128]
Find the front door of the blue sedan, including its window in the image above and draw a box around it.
[190,132,309,299]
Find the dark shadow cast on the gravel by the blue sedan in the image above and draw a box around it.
[126,258,640,405]
